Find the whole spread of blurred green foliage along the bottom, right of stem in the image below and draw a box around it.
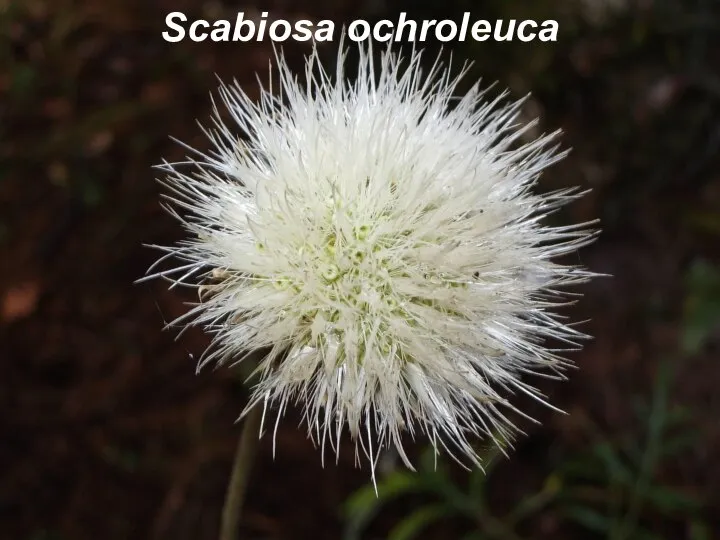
[344,364,710,540]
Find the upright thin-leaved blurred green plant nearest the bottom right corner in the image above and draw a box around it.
[557,363,701,540]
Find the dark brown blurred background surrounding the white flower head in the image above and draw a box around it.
[0,0,720,540]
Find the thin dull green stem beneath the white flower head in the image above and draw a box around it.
[220,406,262,540]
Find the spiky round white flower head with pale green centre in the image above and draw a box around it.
[146,41,593,471]
